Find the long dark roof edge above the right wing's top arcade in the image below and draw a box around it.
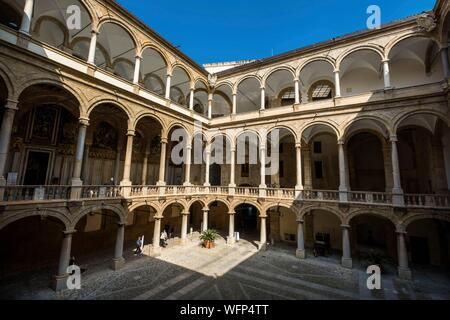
[217,10,428,78]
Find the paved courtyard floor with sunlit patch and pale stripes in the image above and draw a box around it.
[0,235,450,300]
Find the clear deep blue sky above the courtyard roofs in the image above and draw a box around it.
[117,0,435,64]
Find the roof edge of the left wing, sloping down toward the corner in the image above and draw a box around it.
[107,0,209,76]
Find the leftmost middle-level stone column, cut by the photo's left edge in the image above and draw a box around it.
[0,100,17,186]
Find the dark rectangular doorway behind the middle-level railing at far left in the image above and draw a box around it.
[23,151,50,186]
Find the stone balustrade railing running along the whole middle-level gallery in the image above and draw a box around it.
[0,185,450,209]
